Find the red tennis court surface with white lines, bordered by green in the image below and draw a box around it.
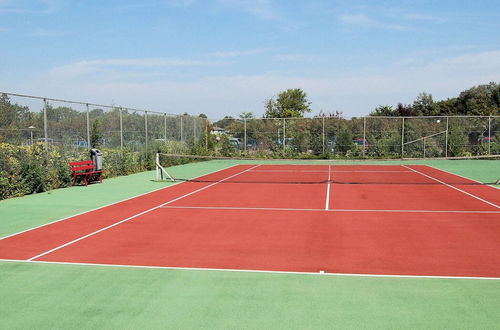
[0,165,500,278]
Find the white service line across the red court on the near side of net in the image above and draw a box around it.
[161,206,500,214]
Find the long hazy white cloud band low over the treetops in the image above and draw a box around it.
[8,50,500,118]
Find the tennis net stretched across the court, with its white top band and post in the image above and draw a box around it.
[156,153,500,186]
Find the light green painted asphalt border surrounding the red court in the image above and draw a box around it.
[0,160,500,329]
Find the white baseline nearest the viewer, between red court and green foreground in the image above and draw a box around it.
[0,259,500,281]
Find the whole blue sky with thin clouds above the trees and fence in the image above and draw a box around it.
[0,0,500,118]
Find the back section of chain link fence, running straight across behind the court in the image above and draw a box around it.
[210,116,500,159]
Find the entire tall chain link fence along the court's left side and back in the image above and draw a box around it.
[0,93,500,158]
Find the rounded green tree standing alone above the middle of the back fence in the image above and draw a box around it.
[264,88,311,118]
